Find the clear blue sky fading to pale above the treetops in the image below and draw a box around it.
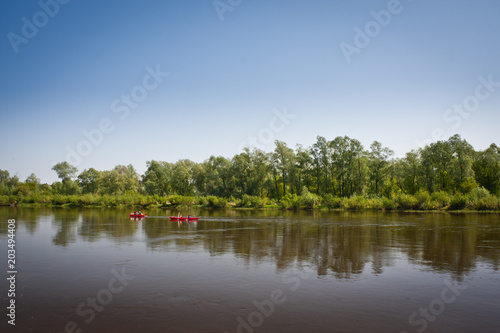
[0,0,500,183]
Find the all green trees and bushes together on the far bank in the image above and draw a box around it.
[0,135,500,212]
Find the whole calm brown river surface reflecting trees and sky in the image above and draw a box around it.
[0,208,500,333]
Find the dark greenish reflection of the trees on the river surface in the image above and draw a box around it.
[0,208,500,279]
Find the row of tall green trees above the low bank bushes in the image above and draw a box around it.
[0,135,500,208]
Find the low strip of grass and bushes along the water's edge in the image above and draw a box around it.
[0,189,500,211]
